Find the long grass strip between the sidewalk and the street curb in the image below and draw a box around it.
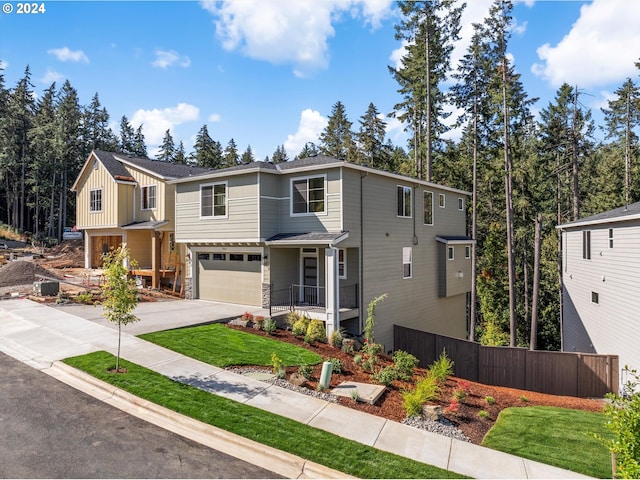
[64,352,464,478]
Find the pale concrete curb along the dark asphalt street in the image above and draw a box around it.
[47,361,357,479]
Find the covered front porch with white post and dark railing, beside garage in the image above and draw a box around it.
[263,232,360,335]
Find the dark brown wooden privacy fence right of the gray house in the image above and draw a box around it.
[393,325,619,398]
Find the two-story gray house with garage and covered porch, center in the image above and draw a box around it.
[169,156,474,350]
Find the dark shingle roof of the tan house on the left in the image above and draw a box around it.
[94,150,213,180]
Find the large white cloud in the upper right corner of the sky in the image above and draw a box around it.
[531,0,640,87]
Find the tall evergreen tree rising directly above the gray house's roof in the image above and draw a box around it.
[389,0,465,181]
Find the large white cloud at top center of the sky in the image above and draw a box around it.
[200,0,392,77]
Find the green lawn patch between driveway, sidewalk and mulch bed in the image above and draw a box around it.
[140,323,322,368]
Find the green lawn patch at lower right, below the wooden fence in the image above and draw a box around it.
[482,407,611,478]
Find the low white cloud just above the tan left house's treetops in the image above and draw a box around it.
[129,103,200,146]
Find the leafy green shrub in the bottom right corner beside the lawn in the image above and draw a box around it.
[597,367,640,478]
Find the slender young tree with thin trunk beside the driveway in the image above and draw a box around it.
[102,246,140,373]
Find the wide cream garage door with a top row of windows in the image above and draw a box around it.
[198,253,262,307]
